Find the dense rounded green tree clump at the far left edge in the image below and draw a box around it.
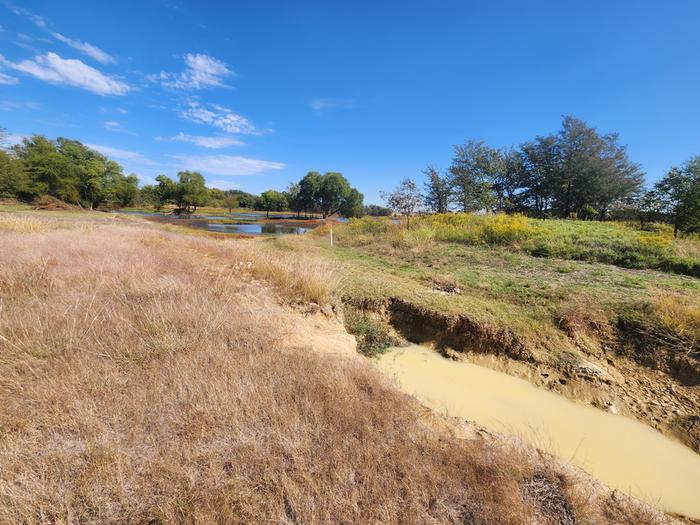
[0,130,139,209]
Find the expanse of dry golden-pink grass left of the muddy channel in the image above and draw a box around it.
[0,211,668,524]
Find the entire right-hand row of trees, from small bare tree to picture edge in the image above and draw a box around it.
[394,116,700,233]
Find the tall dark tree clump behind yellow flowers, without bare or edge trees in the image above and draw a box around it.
[424,116,644,219]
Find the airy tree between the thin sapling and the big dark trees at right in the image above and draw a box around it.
[449,140,501,212]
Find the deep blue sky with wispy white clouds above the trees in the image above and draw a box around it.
[0,0,700,203]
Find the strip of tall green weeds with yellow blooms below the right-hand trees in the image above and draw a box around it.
[335,213,700,277]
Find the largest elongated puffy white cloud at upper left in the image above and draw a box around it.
[0,53,131,96]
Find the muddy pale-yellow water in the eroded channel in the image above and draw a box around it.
[377,345,700,518]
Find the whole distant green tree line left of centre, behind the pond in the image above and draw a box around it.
[0,129,370,218]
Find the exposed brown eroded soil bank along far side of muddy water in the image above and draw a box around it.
[346,298,700,453]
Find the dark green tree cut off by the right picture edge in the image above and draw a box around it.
[653,156,700,237]
